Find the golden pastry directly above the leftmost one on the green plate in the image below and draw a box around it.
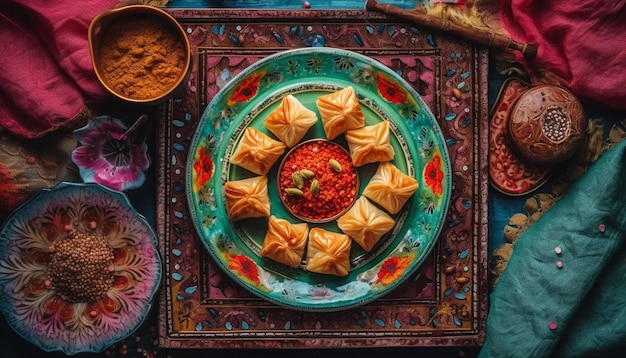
[230,127,286,175]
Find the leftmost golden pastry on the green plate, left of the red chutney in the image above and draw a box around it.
[224,175,270,221]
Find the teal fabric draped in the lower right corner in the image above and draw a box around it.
[479,141,626,358]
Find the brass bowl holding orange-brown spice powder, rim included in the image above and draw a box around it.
[88,5,191,104]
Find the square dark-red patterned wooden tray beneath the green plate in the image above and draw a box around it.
[157,9,488,348]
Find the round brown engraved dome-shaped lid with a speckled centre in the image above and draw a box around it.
[508,85,587,165]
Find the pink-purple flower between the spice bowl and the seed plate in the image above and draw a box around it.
[72,116,150,191]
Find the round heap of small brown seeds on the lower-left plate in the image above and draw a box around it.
[48,230,114,302]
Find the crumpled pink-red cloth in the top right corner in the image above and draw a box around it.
[501,0,626,109]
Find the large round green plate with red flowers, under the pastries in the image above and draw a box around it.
[186,48,451,311]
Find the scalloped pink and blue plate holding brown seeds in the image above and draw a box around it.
[0,183,162,354]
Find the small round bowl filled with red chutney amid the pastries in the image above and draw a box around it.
[276,138,360,224]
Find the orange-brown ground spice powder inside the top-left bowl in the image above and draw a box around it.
[98,16,186,100]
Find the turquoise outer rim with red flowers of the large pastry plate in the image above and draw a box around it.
[185,47,452,312]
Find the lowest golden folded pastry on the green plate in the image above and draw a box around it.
[306,227,352,276]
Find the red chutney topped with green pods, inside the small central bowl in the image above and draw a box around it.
[278,139,359,222]
